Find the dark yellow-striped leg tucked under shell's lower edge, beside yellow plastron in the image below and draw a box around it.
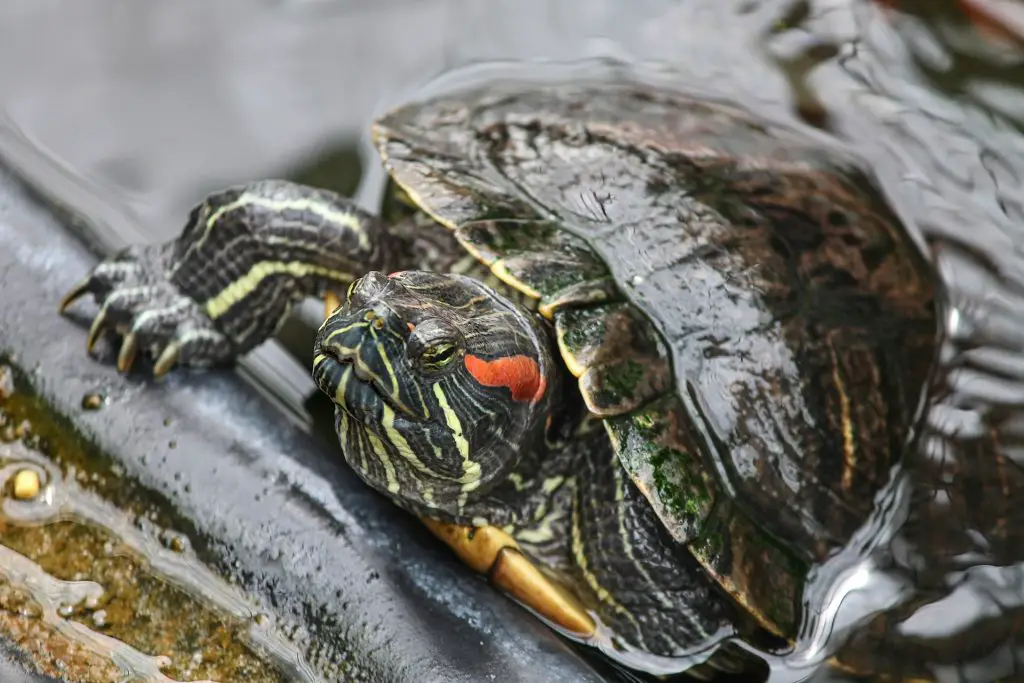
[513,429,756,678]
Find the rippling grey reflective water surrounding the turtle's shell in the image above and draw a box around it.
[0,0,1024,681]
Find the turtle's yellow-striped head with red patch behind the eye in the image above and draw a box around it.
[313,270,557,523]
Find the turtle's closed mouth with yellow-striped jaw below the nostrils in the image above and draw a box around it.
[313,346,423,422]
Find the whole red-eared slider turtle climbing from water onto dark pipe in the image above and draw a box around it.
[56,70,936,671]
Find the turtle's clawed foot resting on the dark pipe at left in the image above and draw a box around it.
[60,245,233,377]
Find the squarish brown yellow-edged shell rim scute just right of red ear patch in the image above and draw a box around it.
[554,303,673,417]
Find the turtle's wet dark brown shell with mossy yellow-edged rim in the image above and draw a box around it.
[373,70,937,636]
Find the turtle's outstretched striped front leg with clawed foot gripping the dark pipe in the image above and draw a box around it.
[60,180,407,376]
